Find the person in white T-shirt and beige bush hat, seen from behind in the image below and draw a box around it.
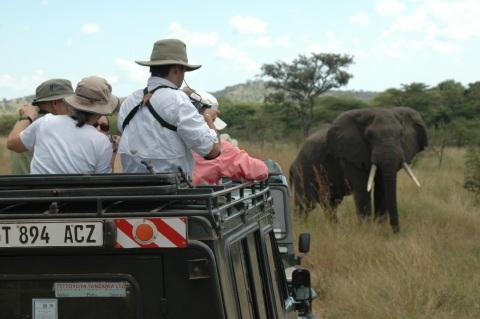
[7,76,119,174]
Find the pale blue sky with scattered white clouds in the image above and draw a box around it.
[0,0,480,98]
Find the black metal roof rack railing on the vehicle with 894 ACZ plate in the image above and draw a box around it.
[0,173,271,234]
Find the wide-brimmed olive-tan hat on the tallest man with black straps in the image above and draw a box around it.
[135,39,201,71]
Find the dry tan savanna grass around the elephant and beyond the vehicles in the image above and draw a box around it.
[0,139,480,319]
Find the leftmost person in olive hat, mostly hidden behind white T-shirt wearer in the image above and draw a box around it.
[10,79,73,175]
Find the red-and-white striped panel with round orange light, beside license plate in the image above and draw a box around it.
[115,217,187,248]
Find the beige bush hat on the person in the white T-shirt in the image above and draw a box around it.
[64,76,120,115]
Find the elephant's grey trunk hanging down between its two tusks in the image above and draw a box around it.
[382,164,400,233]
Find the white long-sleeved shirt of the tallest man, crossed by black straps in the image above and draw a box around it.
[117,77,218,176]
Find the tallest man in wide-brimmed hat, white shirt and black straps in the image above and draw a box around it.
[118,39,220,177]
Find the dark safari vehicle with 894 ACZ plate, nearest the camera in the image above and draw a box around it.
[0,174,312,319]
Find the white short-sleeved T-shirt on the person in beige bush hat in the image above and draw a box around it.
[20,114,113,174]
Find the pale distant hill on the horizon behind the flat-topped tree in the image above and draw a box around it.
[213,81,379,102]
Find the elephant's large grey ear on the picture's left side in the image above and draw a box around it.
[327,110,371,169]
